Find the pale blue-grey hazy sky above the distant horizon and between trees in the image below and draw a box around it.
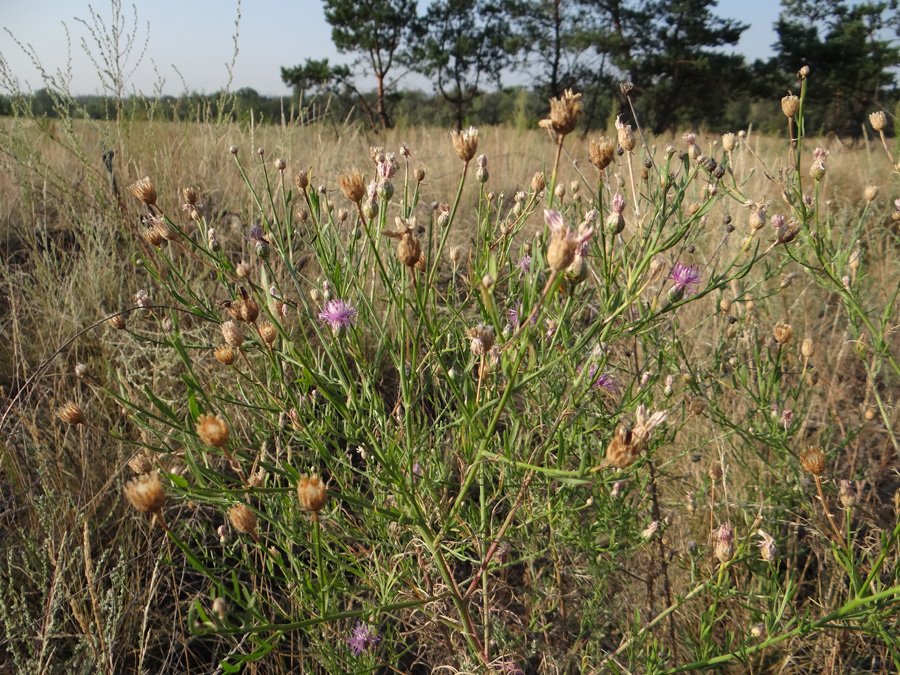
[0,0,780,96]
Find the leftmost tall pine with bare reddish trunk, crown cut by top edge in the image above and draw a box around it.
[323,0,417,129]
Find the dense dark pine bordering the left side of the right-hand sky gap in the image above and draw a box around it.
[620,0,749,133]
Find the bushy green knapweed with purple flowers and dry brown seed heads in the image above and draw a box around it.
[8,73,900,673]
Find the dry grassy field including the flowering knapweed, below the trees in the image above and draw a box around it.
[0,84,900,675]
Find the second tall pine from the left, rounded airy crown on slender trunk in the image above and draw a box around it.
[412,0,509,129]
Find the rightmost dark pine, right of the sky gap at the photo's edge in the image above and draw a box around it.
[775,0,900,135]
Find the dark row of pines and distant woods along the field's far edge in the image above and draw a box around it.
[7,0,900,135]
